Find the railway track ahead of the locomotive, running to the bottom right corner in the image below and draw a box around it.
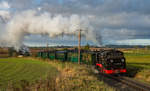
[102,74,150,91]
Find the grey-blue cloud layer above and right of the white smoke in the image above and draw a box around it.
[0,0,150,43]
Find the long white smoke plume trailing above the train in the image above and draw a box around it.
[0,10,99,49]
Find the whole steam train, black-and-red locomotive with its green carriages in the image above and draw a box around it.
[37,49,127,74]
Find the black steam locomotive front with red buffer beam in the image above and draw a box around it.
[96,50,126,74]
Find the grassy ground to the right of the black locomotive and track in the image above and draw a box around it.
[125,49,150,84]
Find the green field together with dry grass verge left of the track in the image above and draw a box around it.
[0,58,115,91]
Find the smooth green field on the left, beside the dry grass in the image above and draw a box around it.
[0,58,58,88]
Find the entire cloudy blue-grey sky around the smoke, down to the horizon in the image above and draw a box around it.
[0,0,150,46]
